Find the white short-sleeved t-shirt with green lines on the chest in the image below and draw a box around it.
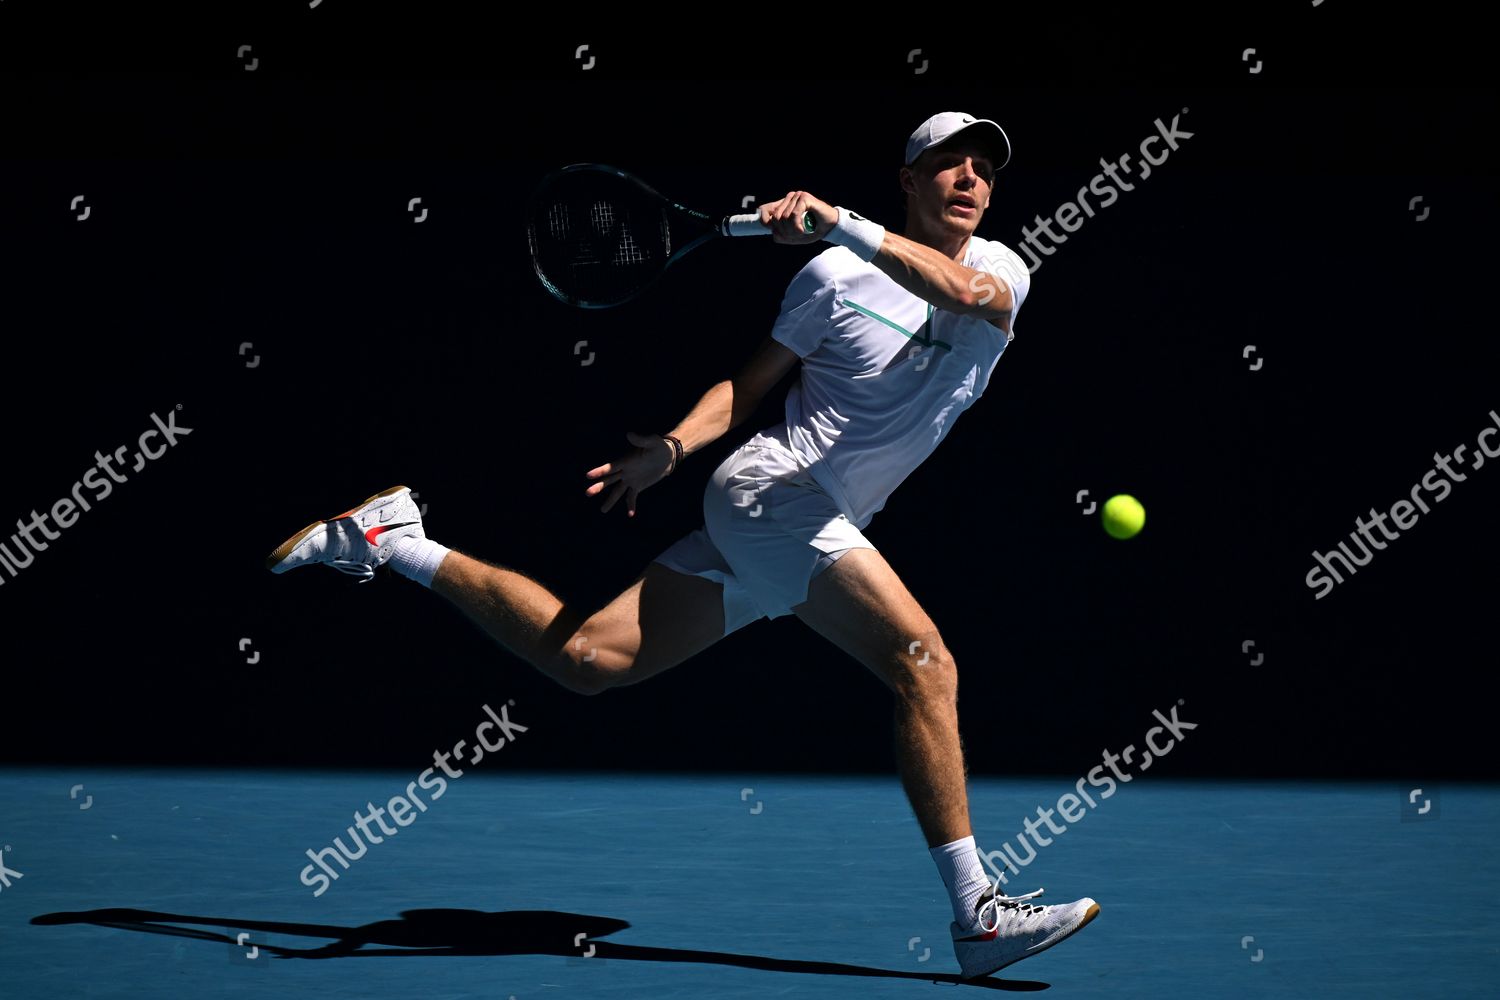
[767,237,1031,528]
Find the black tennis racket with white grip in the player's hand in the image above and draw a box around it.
[527,163,818,309]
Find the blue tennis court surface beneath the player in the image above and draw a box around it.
[0,769,1500,1000]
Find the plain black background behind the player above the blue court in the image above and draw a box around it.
[0,7,1500,778]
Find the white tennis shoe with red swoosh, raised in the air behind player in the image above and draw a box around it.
[266,486,426,583]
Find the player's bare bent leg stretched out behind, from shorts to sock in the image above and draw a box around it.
[432,552,725,694]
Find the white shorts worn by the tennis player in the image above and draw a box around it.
[653,429,875,636]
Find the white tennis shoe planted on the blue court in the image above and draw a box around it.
[950,883,1100,979]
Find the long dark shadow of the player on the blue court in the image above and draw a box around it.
[32,909,1050,993]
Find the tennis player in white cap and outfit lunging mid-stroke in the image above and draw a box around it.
[267,111,1100,978]
